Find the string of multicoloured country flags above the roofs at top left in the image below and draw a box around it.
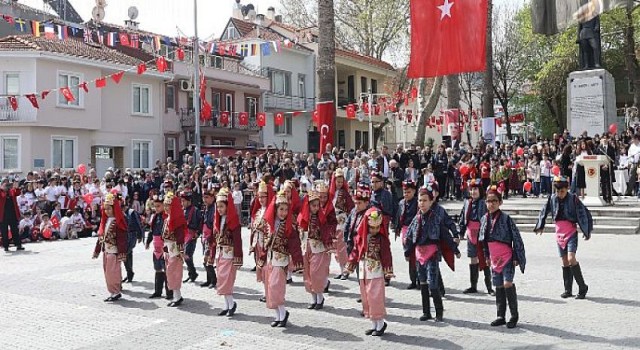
[0,14,294,57]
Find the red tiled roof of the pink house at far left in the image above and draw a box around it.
[0,35,155,68]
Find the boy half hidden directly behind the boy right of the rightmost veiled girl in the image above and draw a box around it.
[394,181,418,289]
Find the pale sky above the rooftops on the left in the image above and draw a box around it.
[19,0,524,39]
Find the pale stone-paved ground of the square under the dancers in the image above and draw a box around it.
[0,230,640,350]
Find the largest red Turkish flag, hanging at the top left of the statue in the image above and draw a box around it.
[408,0,488,78]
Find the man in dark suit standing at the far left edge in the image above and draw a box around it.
[0,178,24,252]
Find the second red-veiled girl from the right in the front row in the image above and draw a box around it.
[298,191,334,310]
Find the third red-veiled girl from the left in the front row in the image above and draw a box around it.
[213,188,243,317]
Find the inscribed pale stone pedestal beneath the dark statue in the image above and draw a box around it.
[567,69,617,137]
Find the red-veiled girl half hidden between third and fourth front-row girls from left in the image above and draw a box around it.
[249,182,274,303]
